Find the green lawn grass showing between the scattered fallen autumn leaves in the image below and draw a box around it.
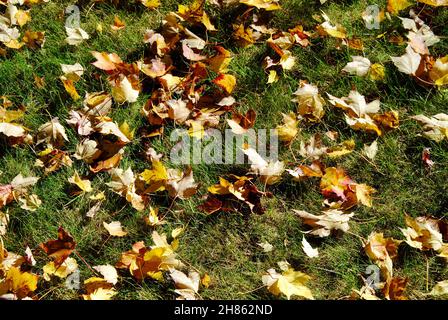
[0,0,448,299]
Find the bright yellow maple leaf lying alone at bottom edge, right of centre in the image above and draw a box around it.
[262,262,314,300]
